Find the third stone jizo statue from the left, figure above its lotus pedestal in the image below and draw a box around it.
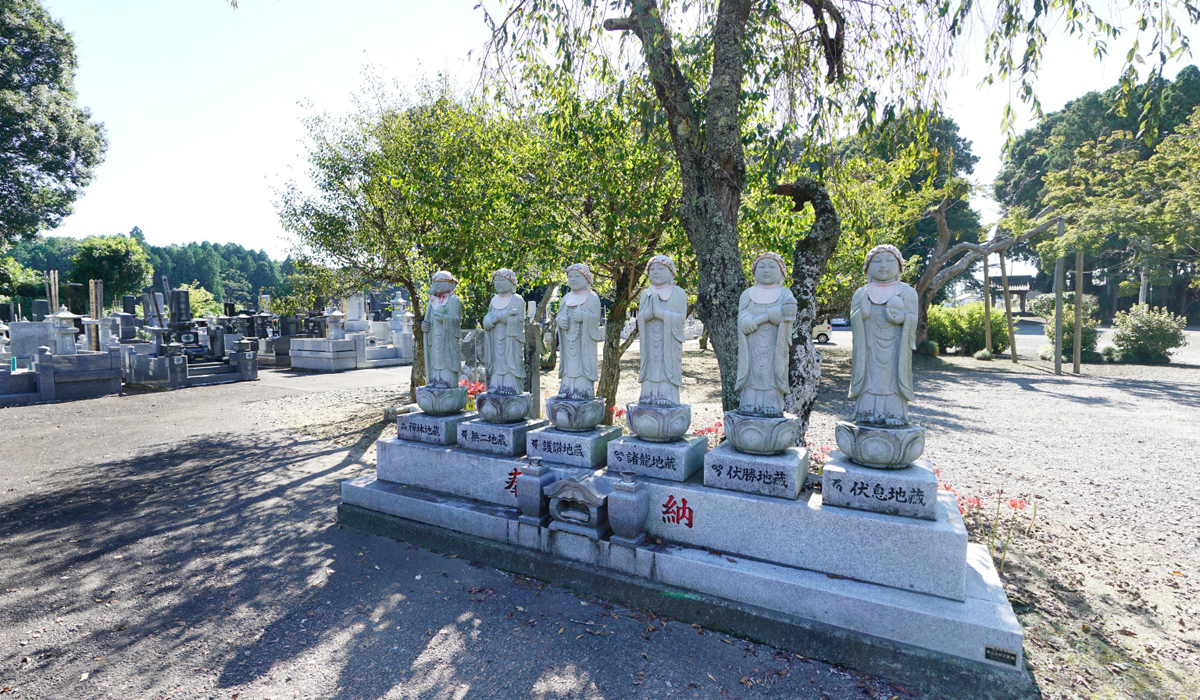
[558,263,602,401]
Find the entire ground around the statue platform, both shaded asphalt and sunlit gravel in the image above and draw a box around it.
[0,329,1200,700]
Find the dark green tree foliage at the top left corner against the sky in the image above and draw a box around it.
[0,0,106,247]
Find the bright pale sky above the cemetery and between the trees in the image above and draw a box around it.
[43,0,1200,257]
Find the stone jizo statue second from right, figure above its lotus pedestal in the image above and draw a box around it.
[734,252,796,415]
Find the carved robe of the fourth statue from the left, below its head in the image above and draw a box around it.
[637,285,688,406]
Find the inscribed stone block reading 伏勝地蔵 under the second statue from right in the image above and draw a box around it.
[704,441,809,499]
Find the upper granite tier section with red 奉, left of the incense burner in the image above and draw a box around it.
[376,437,593,506]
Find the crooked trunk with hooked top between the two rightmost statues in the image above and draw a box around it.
[775,178,841,434]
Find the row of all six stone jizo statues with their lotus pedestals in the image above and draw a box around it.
[405,246,924,468]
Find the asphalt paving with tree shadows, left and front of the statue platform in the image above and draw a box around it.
[0,367,906,700]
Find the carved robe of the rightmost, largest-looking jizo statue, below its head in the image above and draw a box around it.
[850,282,917,425]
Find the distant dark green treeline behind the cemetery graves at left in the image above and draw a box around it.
[8,228,290,305]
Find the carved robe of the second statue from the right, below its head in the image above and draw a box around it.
[733,286,796,415]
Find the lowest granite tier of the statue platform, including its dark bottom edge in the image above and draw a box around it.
[338,480,1037,700]
